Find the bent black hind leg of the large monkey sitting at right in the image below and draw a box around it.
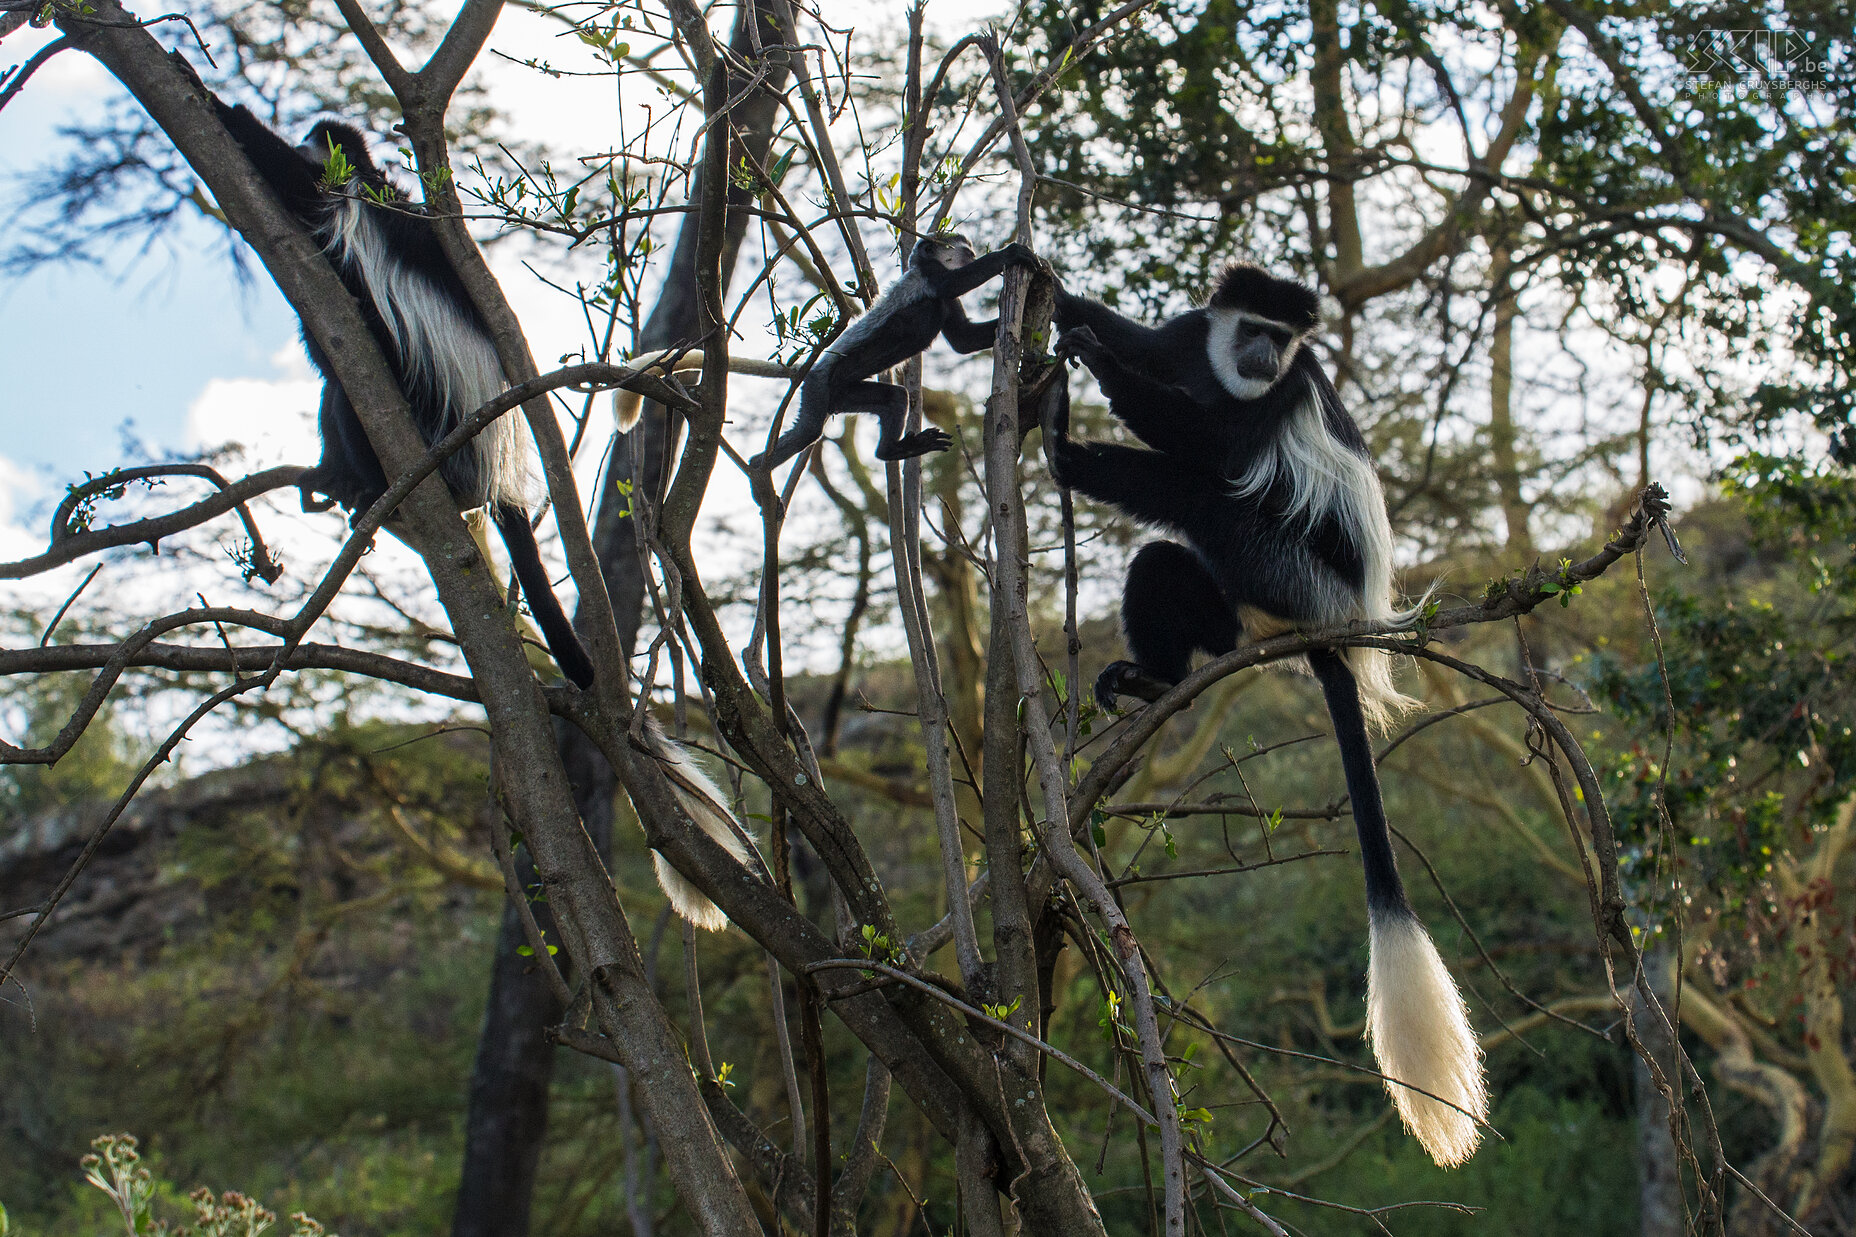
[1095,540,1238,710]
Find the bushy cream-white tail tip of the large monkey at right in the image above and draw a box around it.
[1366,910,1489,1168]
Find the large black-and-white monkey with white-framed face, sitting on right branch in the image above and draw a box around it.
[1049,264,1489,1166]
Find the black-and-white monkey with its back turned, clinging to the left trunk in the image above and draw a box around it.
[213,97,594,687]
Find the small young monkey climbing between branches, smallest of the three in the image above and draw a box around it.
[750,232,1038,468]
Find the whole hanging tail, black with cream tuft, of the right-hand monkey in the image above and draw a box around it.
[1308,650,1489,1168]
